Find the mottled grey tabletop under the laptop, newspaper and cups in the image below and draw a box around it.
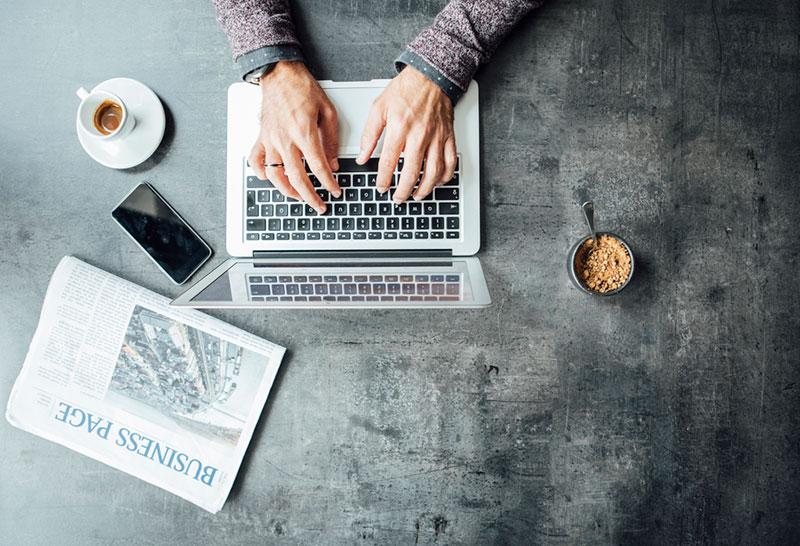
[0,0,800,545]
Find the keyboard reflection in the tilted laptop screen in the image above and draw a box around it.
[247,273,462,302]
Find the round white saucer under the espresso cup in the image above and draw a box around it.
[76,78,167,169]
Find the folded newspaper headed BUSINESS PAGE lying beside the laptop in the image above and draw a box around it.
[6,257,285,512]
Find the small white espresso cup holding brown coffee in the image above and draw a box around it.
[76,87,136,140]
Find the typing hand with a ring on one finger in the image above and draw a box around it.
[249,61,342,214]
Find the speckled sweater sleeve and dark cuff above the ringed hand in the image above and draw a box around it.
[213,0,303,76]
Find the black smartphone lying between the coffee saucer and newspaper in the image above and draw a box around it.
[111,183,212,284]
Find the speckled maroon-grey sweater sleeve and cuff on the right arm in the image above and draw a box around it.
[395,0,544,102]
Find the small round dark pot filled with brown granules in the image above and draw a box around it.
[575,235,631,293]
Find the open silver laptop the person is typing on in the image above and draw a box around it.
[172,80,491,308]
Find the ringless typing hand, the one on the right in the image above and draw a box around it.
[358,66,456,203]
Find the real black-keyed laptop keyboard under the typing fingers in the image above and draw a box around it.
[245,157,461,241]
